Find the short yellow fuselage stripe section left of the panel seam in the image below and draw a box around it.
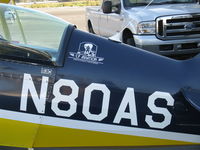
[0,119,39,147]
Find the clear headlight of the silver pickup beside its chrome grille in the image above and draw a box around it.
[138,21,156,34]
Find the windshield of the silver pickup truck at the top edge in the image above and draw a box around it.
[124,0,198,7]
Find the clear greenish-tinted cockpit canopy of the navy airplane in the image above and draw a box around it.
[0,4,69,62]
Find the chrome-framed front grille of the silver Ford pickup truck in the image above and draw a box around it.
[156,14,200,40]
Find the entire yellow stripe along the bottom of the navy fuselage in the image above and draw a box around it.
[0,119,193,147]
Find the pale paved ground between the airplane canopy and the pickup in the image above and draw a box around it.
[34,7,86,31]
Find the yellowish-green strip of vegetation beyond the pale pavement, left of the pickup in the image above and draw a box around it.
[23,0,100,8]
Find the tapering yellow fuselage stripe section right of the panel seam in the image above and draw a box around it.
[34,125,192,147]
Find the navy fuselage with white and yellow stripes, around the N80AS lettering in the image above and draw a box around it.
[0,4,200,148]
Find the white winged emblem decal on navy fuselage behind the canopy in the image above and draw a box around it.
[69,42,104,64]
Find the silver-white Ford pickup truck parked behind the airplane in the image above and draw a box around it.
[86,0,200,55]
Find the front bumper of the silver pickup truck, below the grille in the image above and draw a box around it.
[133,35,200,56]
